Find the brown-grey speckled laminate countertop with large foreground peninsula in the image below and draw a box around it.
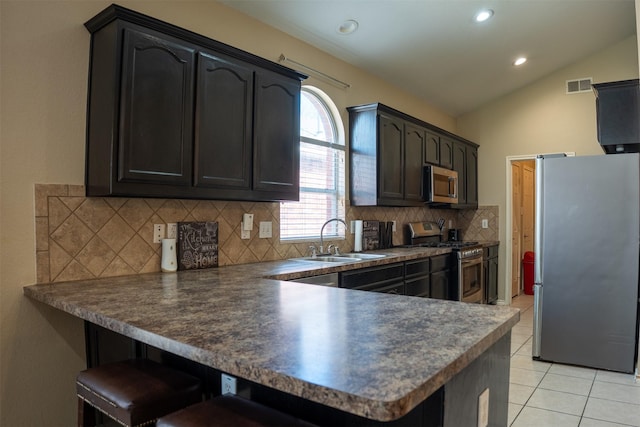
[24,249,519,421]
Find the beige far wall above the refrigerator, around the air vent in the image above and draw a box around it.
[457,36,638,299]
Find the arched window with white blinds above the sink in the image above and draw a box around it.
[280,86,345,240]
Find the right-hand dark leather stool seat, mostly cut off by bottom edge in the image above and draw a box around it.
[156,395,314,427]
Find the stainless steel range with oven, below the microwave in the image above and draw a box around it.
[406,222,485,304]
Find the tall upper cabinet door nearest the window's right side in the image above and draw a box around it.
[378,114,404,200]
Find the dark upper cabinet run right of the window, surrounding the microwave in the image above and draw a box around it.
[347,103,478,208]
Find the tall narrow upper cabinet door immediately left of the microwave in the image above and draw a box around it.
[404,124,426,203]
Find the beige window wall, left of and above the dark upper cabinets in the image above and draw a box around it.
[0,0,455,427]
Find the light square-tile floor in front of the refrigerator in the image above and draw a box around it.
[509,295,640,427]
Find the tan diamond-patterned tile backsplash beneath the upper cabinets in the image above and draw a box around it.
[35,184,498,283]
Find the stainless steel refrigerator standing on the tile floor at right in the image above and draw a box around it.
[533,153,640,372]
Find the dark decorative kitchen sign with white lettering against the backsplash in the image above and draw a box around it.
[178,222,218,270]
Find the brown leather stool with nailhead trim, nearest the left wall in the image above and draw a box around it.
[76,359,202,427]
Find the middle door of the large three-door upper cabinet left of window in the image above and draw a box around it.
[194,52,253,190]
